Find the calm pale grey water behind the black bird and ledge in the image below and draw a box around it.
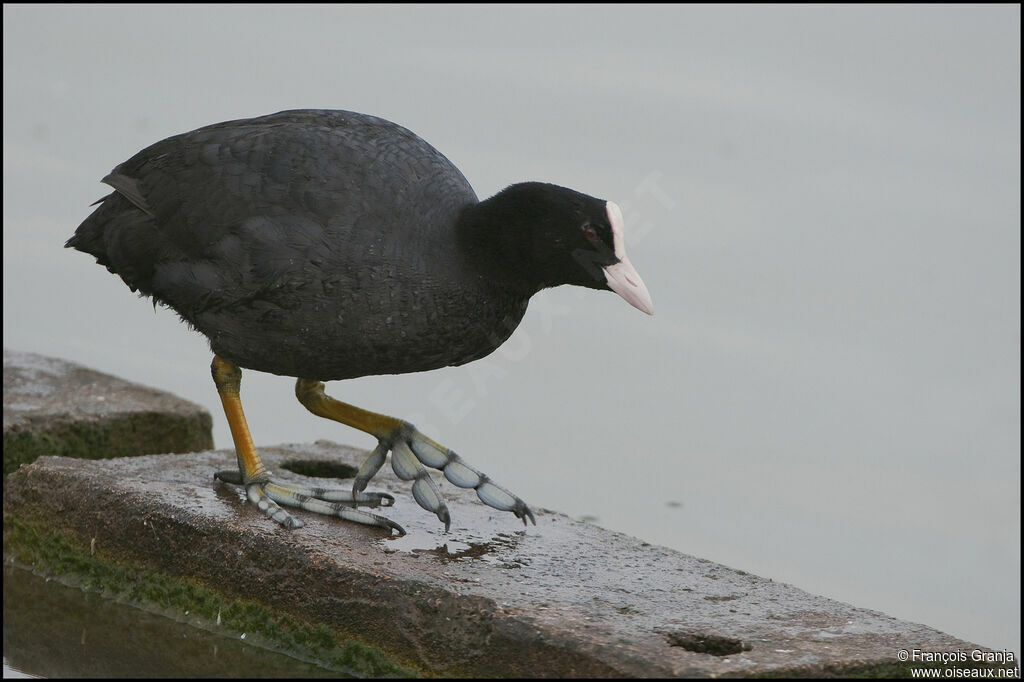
[3,4,1020,674]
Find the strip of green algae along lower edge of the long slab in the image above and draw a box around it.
[3,513,417,677]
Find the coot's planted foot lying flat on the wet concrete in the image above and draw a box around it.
[213,469,406,536]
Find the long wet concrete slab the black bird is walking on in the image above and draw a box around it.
[4,441,1007,677]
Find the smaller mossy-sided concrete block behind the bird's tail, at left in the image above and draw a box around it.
[3,348,213,479]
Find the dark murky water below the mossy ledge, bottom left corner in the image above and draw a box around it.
[3,565,344,678]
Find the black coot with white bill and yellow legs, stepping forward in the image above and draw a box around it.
[66,110,652,534]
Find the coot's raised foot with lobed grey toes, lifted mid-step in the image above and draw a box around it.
[352,422,537,530]
